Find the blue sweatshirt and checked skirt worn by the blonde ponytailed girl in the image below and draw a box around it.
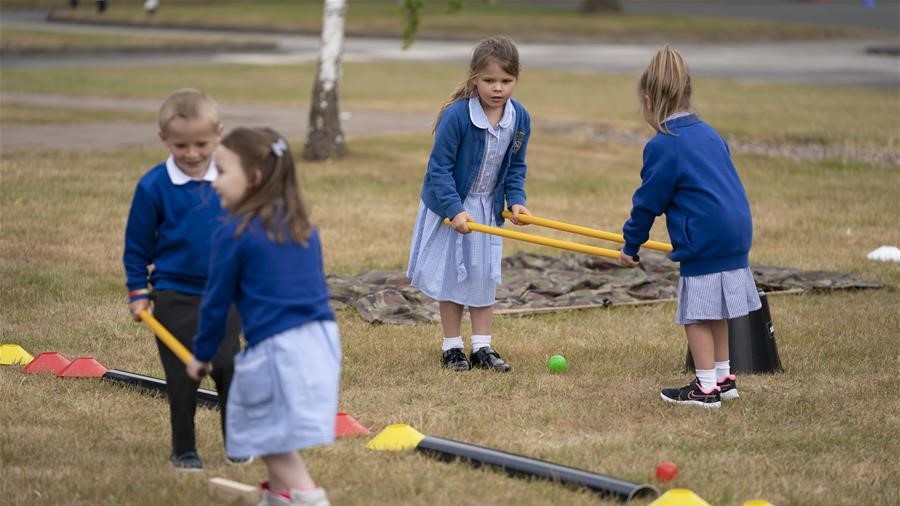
[622,113,761,325]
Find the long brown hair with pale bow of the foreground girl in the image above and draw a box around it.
[221,128,311,244]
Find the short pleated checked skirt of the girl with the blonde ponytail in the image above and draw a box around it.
[675,267,762,325]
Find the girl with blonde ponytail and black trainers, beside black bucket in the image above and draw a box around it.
[619,45,761,408]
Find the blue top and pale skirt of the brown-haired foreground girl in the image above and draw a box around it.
[194,218,341,458]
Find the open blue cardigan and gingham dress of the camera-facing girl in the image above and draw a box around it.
[406,97,530,307]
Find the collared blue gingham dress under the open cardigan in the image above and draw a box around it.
[406,97,516,307]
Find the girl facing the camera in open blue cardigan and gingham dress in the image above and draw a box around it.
[407,37,531,372]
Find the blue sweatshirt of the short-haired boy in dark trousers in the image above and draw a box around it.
[122,162,226,300]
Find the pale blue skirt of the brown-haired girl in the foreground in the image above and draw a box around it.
[225,321,341,458]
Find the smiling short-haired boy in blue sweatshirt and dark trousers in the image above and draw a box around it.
[123,88,240,470]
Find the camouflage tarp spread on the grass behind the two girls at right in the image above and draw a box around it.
[328,251,881,324]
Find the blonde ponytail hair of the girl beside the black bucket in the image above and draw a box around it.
[638,44,691,134]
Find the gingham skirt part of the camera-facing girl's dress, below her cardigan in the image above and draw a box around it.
[406,193,503,307]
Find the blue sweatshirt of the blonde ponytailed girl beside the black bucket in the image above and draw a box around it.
[622,114,753,276]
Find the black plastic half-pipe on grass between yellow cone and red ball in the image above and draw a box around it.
[416,436,659,501]
